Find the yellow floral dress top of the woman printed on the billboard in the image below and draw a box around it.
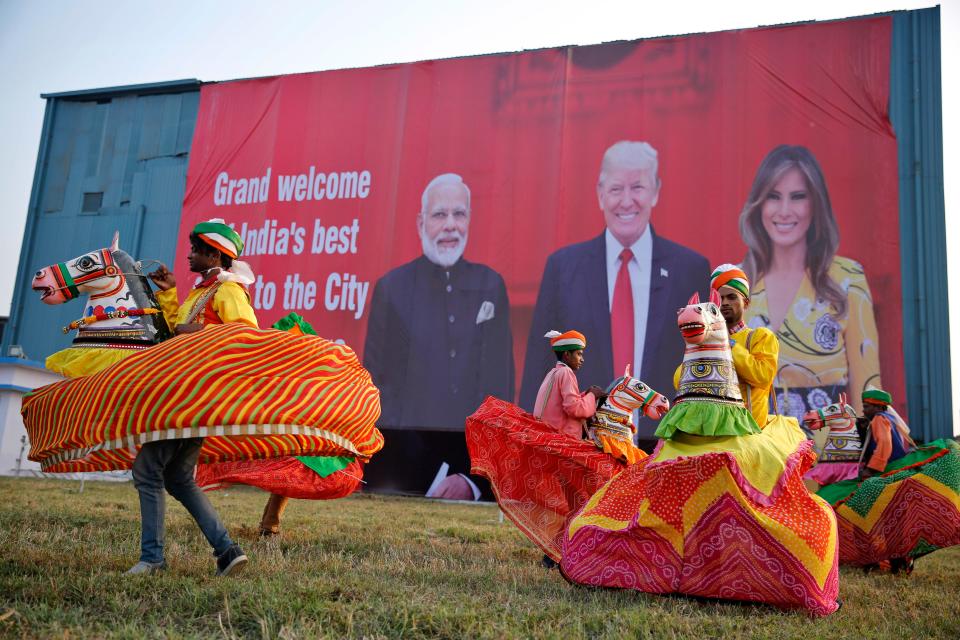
[744,256,883,413]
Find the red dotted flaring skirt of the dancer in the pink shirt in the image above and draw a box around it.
[466,397,624,561]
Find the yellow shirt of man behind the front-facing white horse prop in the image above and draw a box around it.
[673,328,780,429]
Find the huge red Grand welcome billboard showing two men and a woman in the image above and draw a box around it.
[175,17,906,496]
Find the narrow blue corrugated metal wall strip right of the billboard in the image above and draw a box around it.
[890,8,956,440]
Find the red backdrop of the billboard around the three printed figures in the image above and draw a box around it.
[175,17,906,427]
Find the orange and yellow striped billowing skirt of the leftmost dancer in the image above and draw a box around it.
[22,322,383,472]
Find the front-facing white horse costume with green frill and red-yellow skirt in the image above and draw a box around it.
[560,291,839,615]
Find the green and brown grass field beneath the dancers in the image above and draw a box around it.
[0,478,960,640]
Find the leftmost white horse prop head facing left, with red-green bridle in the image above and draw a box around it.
[32,232,170,343]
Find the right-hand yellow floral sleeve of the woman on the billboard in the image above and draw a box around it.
[843,262,882,412]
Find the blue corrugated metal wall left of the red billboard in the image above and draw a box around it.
[3,81,200,361]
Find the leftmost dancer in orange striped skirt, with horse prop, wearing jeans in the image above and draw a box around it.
[22,220,383,573]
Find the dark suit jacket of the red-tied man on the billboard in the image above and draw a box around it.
[520,227,710,437]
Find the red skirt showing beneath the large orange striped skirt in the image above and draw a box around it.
[196,457,363,500]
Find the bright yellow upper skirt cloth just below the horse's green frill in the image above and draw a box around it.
[651,416,806,495]
